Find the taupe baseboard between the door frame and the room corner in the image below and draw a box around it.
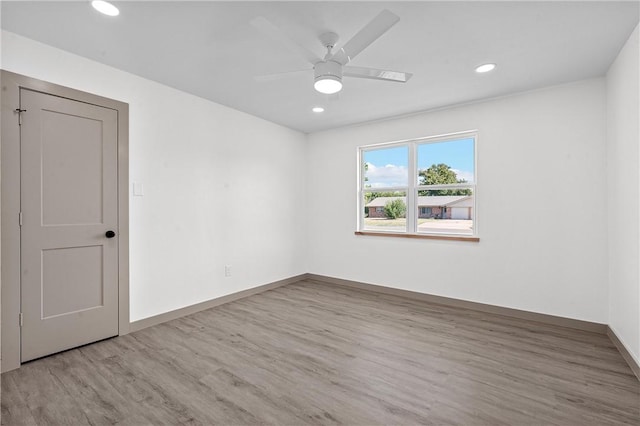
[130,274,308,333]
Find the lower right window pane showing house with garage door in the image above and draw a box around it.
[417,188,475,235]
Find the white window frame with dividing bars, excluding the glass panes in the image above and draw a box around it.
[356,130,479,241]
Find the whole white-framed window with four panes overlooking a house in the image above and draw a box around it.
[358,132,477,237]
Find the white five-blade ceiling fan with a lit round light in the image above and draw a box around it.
[251,9,413,95]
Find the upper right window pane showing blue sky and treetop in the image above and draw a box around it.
[418,138,474,185]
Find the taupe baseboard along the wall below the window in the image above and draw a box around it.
[307,274,607,334]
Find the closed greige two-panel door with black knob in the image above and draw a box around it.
[20,89,118,362]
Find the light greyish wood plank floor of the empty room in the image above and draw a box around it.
[2,280,640,426]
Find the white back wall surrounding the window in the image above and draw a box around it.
[308,79,608,323]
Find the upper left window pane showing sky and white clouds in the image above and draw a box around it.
[363,146,409,188]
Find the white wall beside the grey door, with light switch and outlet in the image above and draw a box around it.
[2,32,307,321]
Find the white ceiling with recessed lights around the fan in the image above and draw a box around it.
[1,1,639,133]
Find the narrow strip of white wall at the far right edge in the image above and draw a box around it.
[606,23,640,364]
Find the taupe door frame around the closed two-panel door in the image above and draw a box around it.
[0,70,129,372]
